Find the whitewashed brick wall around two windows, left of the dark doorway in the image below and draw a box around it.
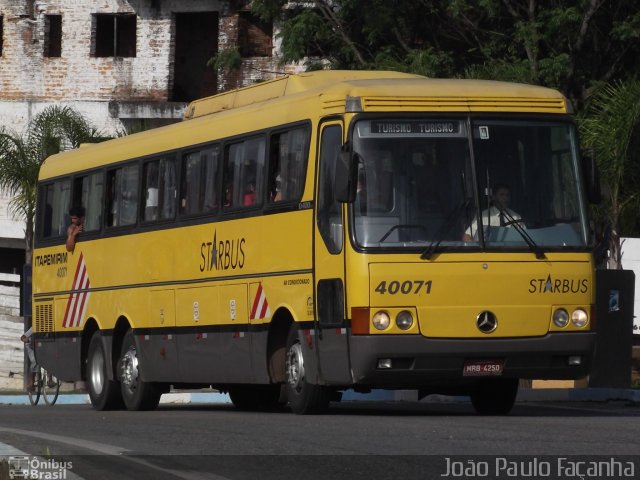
[0,0,220,101]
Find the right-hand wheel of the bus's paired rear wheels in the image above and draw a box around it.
[118,330,162,410]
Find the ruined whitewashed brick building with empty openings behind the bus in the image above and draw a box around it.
[0,0,304,272]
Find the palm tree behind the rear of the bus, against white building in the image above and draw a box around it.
[0,106,104,264]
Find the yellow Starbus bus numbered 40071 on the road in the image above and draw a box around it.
[33,71,597,414]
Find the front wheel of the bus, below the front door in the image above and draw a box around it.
[285,324,331,415]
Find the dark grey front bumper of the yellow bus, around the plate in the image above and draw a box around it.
[349,332,596,389]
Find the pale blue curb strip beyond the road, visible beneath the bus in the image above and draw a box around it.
[0,388,640,406]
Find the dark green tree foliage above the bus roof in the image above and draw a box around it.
[252,0,640,108]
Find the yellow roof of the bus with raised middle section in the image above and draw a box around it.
[40,70,568,179]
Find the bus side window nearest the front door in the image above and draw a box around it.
[267,127,308,203]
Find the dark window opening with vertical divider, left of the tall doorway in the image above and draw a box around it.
[93,14,136,57]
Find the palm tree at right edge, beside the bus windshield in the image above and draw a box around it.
[580,79,640,270]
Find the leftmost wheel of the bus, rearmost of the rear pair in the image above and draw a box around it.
[87,331,122,410]
